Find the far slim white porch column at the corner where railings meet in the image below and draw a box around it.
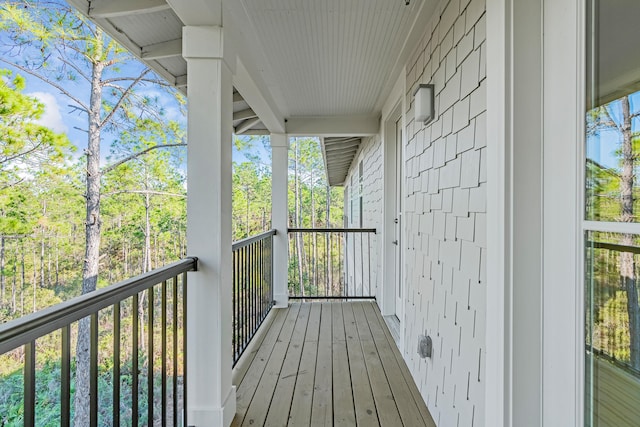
[271,133,289,308]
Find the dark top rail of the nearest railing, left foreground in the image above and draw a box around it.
[0,257,198,354]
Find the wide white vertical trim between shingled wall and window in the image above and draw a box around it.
[484,0,584,426]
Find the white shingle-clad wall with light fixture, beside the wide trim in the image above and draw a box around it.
[403,0,486,427]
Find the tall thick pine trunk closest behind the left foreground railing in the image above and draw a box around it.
[73,59,105,427]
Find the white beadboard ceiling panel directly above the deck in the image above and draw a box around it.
[239,0,420,117]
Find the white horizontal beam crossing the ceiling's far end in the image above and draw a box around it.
[286,116,380,138]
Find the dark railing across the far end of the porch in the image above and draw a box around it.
[289,228,376,300]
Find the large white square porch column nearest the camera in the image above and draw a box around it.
[183,26,236,427]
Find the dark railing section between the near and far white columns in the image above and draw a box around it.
[233,230,276,366]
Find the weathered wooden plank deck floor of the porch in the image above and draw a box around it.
[232,302,435,427]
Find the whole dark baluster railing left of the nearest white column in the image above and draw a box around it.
[0,258,197,426]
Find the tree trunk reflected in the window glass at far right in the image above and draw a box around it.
[620,96,640,369]
